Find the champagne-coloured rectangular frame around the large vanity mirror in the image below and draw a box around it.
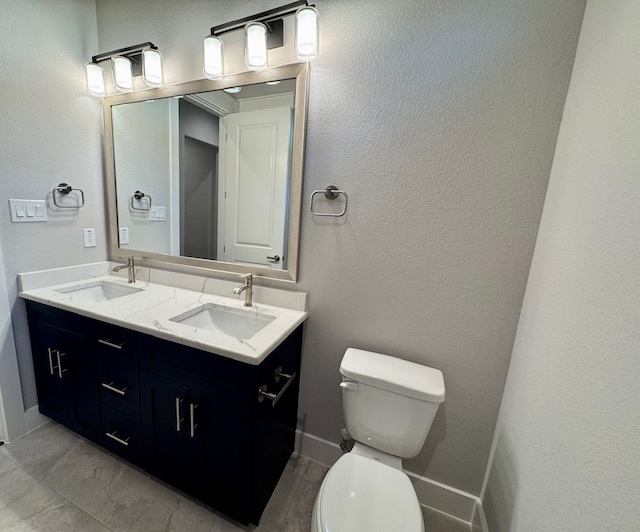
[103,63,309,282]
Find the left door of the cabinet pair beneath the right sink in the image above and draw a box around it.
[140,371,191,486]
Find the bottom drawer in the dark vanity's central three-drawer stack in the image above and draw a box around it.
[102,405,142,465]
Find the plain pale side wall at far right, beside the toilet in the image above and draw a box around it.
[483,0,640,532]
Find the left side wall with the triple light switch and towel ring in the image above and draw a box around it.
[0,0,107,408]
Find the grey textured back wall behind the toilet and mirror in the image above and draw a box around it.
[97,0,584,494]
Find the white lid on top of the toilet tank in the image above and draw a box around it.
[340,347,444,403]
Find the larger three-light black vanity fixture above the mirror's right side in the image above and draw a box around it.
[204,0,318,79]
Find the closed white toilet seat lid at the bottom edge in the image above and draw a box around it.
[313,453,424,532]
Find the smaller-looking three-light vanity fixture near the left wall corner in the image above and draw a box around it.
[85,42,164,96]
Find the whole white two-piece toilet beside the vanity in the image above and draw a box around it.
[311,348,444,532]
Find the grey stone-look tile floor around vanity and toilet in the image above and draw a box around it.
[0,422,470,532]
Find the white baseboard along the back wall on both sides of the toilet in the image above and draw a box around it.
[295,430,488,532]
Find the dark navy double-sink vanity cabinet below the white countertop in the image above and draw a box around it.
[27,301,302,524]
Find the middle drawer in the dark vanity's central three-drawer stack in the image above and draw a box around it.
[98,352,140,418]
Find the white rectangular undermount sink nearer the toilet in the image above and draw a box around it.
[169,303,276,340]
